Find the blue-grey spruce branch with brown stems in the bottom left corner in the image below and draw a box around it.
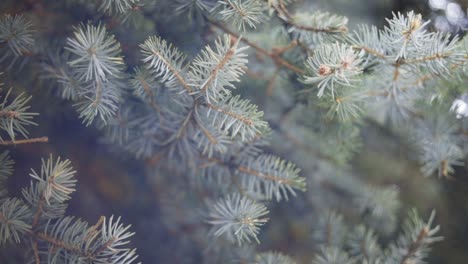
[0,156,137,264]
